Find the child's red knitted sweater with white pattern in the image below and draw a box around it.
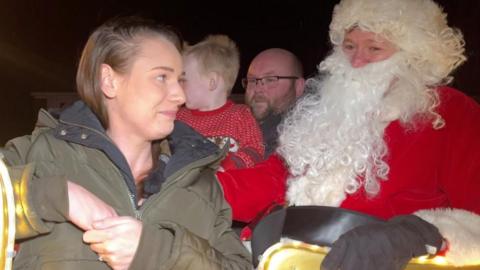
[177,100,264,170]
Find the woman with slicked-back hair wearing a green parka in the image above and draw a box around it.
[4,18,251,269]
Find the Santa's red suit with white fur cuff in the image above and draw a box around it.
[218,87,480,265]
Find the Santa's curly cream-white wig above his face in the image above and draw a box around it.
[330,0,466,128]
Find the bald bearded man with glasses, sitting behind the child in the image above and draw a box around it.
[242,48,305,158]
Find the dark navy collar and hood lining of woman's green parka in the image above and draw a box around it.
[54,101,222,202]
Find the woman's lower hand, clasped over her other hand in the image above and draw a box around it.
[83,216,143,270]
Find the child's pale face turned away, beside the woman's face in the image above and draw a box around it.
[183,55,211,110]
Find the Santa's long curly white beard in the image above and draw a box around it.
[278,49,408,206]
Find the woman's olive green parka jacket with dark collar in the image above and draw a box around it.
[2,102,252,270]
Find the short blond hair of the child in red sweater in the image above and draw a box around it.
[183,35,240,94]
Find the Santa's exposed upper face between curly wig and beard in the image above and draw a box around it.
[342,28,397,68]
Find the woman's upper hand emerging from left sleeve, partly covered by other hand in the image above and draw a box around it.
[67,181,117,230]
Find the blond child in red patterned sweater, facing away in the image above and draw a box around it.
[177,35,264,170]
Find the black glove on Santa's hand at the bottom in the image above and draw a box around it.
[321,215,443,270]
